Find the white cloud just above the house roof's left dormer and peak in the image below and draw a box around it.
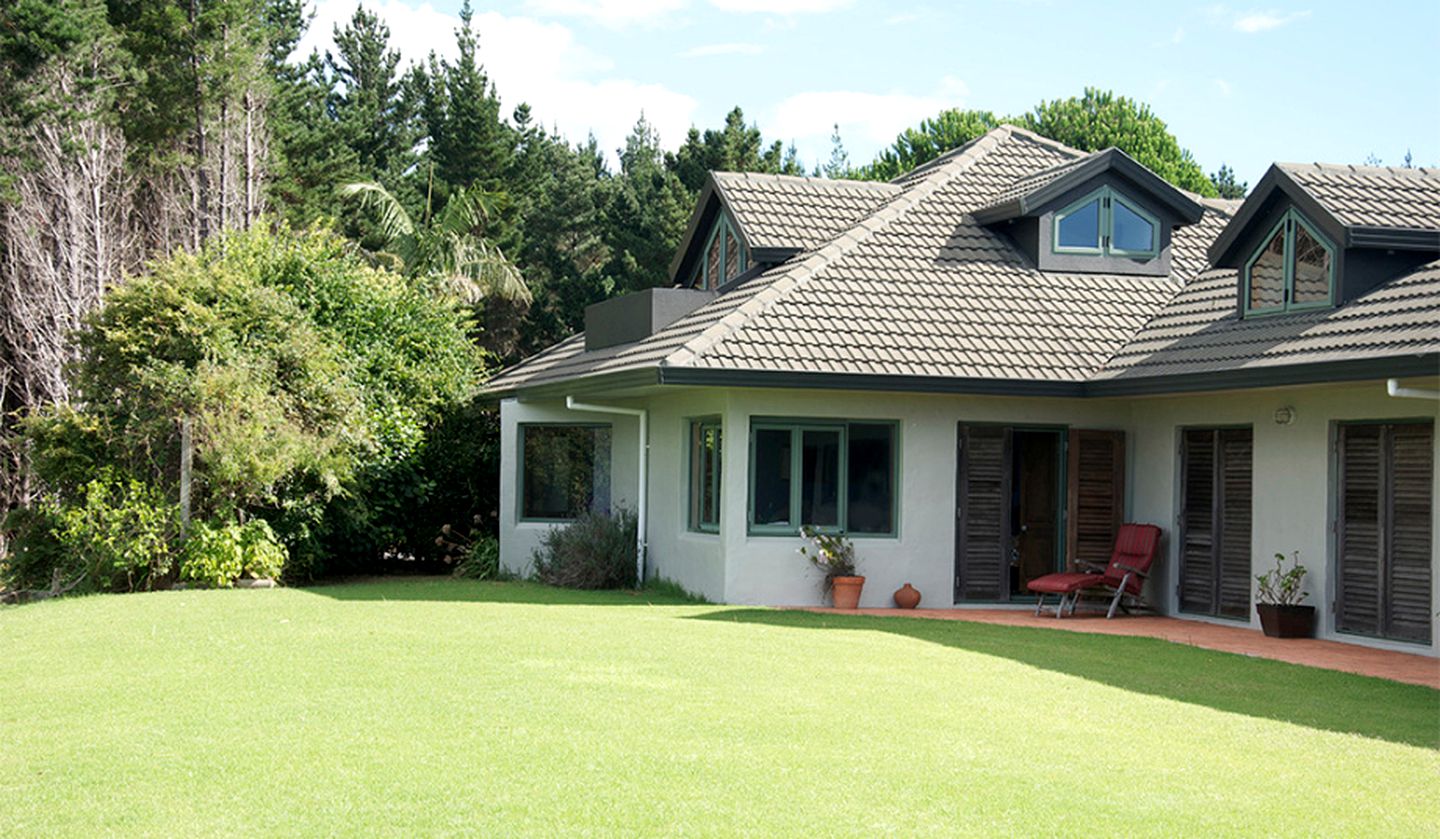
[763,76,969,160]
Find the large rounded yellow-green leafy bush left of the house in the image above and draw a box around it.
[11,225,484,590]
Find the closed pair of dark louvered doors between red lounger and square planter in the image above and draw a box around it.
[1179,429,1254,619]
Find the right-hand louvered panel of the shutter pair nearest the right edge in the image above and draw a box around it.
[1384,423,1434,642]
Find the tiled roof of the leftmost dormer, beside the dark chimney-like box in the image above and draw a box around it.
[714,171,901,250]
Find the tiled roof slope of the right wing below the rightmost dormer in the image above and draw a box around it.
[1094,262,1440,380]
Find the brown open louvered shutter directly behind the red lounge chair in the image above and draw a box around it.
[1066,429,1125,566]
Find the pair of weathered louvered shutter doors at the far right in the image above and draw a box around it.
[1335,423,1434,643]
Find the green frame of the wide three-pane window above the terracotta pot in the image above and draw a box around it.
[746,419,900,538]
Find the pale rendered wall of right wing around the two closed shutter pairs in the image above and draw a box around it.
[1126,381,1440,655]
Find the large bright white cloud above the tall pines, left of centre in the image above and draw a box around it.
[297,0,696,161]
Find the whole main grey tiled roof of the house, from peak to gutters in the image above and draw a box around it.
[488,127,1440,393]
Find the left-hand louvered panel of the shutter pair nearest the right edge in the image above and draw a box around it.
[1335,426,1381,635]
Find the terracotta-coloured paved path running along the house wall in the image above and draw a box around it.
[805,609,1440,689]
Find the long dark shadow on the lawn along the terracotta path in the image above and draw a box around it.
[690,609,1440,748]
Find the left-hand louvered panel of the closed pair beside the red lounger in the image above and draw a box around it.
[1179,429,1220,614]
